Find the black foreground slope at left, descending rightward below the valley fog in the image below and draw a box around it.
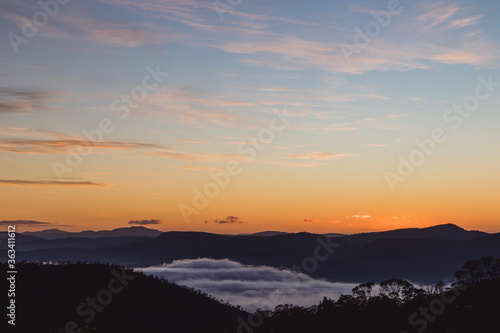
[0,264,246,333]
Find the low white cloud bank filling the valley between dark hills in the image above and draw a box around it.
[137,258,357,311]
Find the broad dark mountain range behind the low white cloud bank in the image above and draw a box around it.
[8,224,500,283]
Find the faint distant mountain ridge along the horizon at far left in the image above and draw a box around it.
[22,226,162,240]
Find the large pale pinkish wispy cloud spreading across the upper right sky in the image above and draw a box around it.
[205,1,499,73]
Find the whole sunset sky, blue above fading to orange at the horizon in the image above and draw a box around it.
[0,0,500,234]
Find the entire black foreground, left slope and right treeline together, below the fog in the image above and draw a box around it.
[0,257,500,333]
